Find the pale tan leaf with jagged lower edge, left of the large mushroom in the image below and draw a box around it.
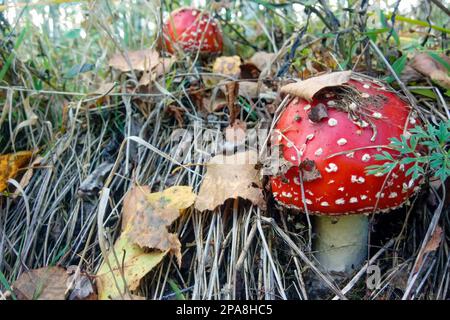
[195,151,266,211]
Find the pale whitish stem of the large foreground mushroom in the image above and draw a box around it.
[314,215,369,274]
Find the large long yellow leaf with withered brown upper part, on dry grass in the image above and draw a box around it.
[97,186,196,300]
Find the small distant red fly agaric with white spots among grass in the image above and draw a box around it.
[163,8,223,53]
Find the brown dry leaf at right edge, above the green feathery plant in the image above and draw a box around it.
[401,53,450,89]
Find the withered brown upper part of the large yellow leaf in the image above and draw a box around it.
[122,186,195,264]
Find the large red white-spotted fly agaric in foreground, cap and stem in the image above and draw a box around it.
[271,77,419,275]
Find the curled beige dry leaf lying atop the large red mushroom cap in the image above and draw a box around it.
[281,71,352,101]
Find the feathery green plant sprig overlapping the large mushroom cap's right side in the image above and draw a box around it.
[366,120,450,181]
